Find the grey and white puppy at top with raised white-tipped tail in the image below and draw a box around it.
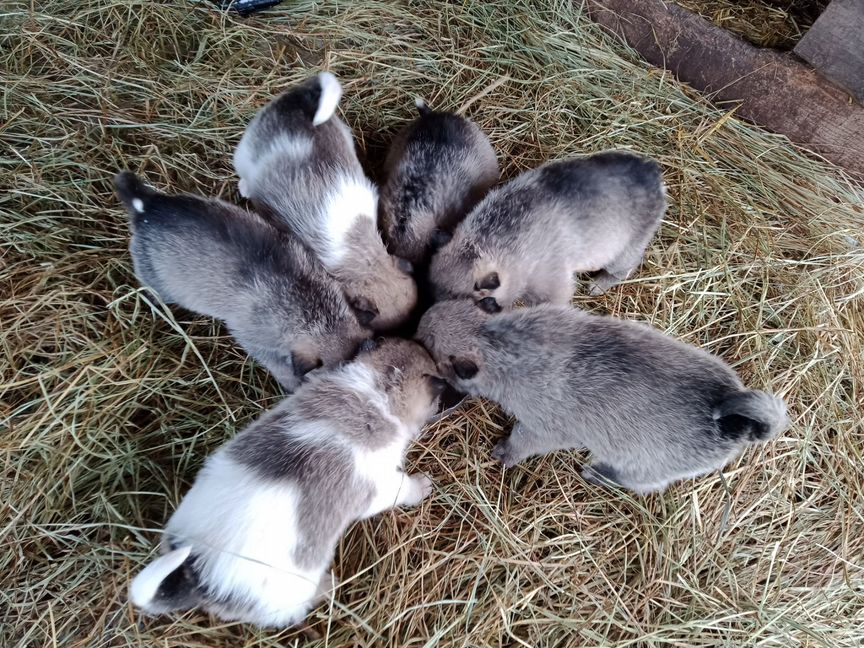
[234,72,417,331]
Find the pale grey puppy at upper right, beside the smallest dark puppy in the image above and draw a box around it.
[429,151,666,312]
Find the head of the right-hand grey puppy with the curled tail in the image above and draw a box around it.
[417,299,490,393]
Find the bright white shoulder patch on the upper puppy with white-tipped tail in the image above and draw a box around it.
[321,176,378,268]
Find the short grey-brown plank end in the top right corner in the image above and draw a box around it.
[795,0,864,101]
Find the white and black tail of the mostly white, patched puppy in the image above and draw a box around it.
[129,546,201,614]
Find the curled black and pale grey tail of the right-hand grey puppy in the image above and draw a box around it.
[713,389,789,443]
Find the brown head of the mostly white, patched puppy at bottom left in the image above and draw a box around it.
[357,338,447,430]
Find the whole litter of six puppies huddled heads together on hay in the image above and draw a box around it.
[115,72,788,626]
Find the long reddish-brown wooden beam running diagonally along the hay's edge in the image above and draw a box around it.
[586,0,864,178]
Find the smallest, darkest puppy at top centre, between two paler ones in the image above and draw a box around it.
[378,99,499,267]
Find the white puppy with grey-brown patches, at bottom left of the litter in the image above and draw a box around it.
[130,339,446,627]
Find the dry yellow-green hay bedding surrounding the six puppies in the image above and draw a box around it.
[0,0,864,648]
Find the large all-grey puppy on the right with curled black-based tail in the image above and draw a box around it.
[417,300,788,493]
